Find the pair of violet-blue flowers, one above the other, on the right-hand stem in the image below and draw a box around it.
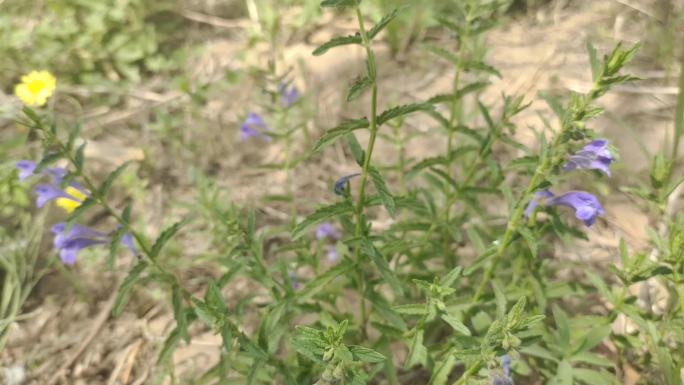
[525,139,614,227]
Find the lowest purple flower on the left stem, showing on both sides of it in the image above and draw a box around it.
[51,223,138,265]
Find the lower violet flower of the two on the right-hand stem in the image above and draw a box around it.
[525,190,605,227]
